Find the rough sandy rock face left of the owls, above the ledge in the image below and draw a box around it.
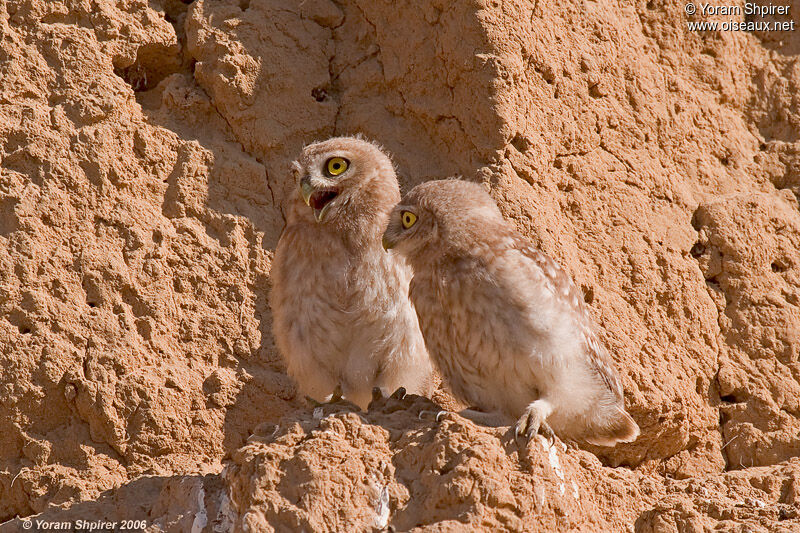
[0,2,293,518]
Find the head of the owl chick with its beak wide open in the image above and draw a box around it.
[292,137,400,230]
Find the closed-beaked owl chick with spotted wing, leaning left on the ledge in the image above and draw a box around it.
[383,180,639,446]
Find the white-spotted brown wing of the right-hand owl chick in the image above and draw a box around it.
[513,235,622,398]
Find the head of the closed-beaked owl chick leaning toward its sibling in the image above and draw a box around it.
[383,179,508,260]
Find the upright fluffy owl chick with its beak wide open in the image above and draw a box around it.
[271,137,433,408]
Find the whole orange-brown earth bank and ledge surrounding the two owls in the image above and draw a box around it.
[0,0,800,533]
